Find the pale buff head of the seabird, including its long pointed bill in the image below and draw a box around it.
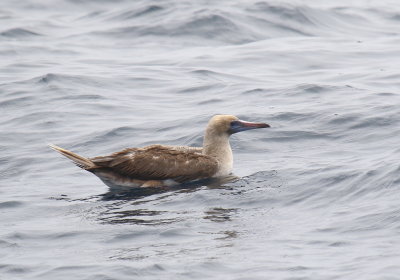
[206,115,270,136]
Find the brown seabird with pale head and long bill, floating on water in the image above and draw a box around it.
[50,115,270,187]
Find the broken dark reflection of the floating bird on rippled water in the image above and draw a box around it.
[58,172,280,229]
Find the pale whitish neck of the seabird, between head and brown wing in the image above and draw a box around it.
[203,131,233,176]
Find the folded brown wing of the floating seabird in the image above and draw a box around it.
[90,145,218,182]
